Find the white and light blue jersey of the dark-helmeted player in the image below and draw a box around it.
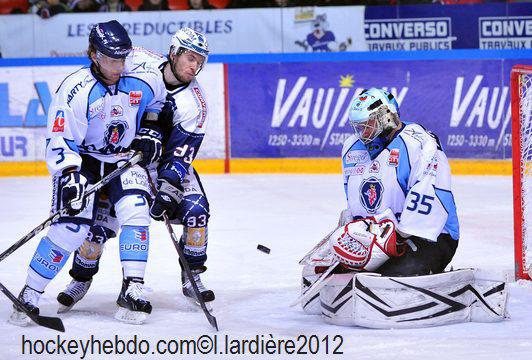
[46,48,166,175]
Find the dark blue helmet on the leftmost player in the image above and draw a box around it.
[89,20,131,59]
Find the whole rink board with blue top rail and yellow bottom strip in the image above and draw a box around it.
[0,50,532,176]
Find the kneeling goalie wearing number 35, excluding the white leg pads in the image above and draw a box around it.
[301,88,459,309]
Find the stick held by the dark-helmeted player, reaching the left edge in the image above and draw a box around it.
[0,152,142,261]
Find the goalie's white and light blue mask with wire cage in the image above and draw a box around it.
[349,88,400,144]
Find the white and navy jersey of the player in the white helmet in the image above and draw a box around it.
[159,72,207,186]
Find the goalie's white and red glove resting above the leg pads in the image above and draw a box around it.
[330,217,405,271]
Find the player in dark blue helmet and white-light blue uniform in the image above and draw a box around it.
[11,20,166,325]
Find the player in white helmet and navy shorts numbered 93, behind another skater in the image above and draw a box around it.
[57,28,214,311]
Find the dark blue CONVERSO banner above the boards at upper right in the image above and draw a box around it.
[364,2,532,51]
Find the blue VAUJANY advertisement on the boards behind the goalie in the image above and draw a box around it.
[229,60,522,159]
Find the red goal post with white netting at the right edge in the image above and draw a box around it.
[510,65,532,280]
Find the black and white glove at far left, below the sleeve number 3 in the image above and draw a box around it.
[59,169,87,216]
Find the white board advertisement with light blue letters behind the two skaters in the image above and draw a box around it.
[0,64,225,161]
